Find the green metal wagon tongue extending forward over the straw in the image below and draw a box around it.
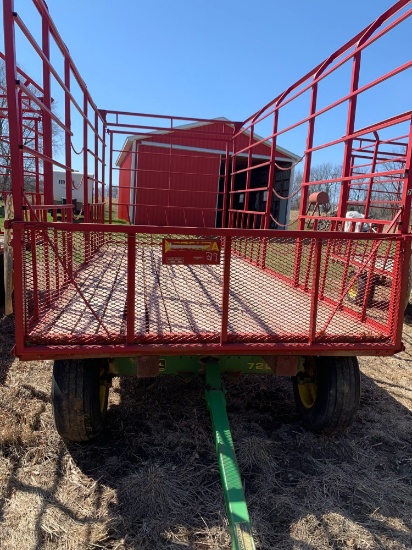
[206,363,256,550]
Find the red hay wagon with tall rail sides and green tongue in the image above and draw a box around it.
[3,0,412,549]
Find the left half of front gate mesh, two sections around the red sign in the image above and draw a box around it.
[23,228,224,345]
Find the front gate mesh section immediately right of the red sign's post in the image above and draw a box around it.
[228,238,310,342]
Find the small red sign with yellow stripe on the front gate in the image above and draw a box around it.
[162,239,221,265]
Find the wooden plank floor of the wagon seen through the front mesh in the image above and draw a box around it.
[26,245,390,345]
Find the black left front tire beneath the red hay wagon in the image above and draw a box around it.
[52,359,109,443]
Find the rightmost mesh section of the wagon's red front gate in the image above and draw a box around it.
[316,239,402,344]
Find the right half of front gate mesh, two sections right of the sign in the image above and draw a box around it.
[228,237,401,347]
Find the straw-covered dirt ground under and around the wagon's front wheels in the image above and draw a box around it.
[0,312,412,550]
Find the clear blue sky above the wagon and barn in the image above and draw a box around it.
[1,0,412,168]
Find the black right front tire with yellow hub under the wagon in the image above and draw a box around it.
[293,357,360,435]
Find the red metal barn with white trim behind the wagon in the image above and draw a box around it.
[116,118,298,227]
